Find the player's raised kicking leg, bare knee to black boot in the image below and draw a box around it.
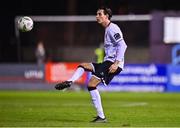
[55,63,93,90]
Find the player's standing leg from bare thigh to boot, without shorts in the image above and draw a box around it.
[88,76,106,122]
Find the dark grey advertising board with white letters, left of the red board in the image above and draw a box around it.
[0,64,45,82]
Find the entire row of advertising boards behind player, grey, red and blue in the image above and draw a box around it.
[0,62,180,92]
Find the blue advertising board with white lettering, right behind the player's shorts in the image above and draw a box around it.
[90,64,167,92]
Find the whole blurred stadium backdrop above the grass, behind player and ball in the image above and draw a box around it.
[0,0,180,92]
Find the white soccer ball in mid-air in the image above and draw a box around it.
[18,16,34,32]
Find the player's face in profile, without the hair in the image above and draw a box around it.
[96,9,108,24]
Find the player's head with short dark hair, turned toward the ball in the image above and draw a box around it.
[96,7,112,24]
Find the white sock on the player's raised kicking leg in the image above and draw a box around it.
[68,67,84,82]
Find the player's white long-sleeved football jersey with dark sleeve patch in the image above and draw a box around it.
[104,23,127,69]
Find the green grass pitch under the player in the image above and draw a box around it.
[0,91,180,127]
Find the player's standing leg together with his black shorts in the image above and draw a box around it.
[88,61,121,122]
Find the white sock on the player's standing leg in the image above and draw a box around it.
[89,89,105,118]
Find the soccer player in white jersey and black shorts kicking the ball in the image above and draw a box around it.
[55,7,127,122]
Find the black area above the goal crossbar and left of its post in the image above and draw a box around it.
[0,0,180,62]
